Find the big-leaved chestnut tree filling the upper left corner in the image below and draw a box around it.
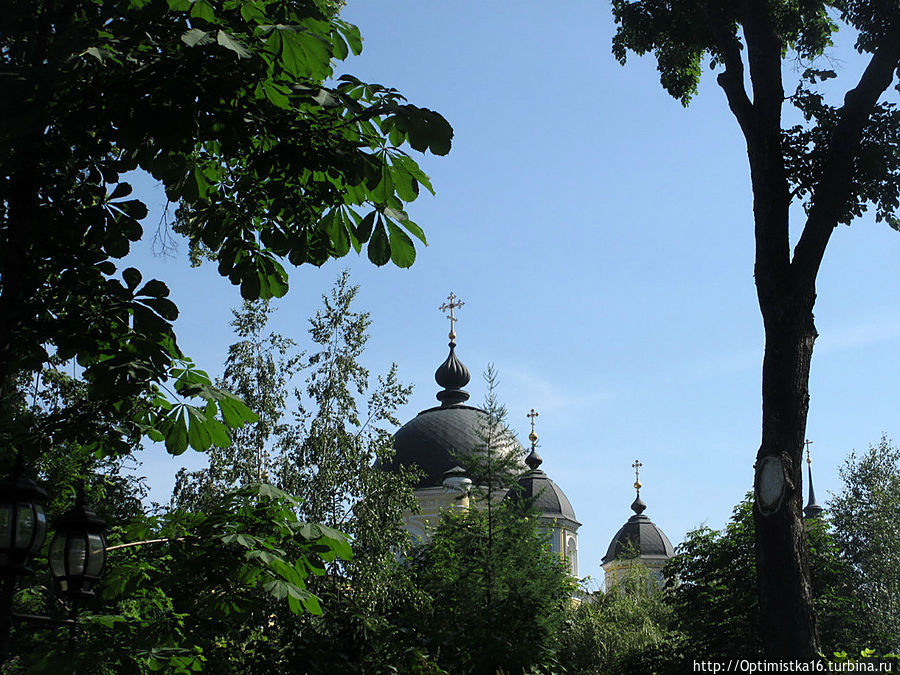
[0,0,452,470]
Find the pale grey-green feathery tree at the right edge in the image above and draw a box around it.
[828,437,900,653]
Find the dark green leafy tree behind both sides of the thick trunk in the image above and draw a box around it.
[664,495,868,672]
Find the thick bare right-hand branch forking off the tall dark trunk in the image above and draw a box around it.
[791,27,900,285]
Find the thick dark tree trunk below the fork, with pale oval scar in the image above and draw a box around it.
[754,291,819,660]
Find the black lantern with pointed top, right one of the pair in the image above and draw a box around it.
[50,490,106,598]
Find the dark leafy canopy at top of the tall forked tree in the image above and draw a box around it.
[612,0,900,229]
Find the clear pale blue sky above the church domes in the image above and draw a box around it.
[133,0,900,581]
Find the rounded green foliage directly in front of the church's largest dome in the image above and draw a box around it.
[407,501,574,675]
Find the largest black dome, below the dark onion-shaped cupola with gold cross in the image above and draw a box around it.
[384,404,522,488]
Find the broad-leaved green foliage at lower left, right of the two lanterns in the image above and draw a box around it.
[12,484,352,673]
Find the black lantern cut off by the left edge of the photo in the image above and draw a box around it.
[0,472,47,576]
